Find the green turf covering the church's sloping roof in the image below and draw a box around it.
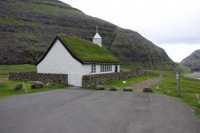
[59,35,119,63]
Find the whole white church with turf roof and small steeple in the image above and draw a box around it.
[36,31,120,86]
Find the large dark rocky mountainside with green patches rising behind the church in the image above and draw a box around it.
[0,0,175,69]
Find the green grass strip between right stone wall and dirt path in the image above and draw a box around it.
[104,75,155,88]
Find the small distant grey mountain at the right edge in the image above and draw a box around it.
[181,49,200,71]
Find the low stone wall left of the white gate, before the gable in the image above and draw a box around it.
[9,72,68,84]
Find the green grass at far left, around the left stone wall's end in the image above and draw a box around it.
[0,64,66,97]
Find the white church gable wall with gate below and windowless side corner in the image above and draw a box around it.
[37,40,91,86]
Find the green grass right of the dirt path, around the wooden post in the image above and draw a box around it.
[153,71,200,117]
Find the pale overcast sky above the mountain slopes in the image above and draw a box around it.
[61,0,200,62]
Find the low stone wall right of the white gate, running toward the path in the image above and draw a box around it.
[82,70,158,87]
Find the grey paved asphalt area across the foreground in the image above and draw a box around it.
[0,89,200,133]
